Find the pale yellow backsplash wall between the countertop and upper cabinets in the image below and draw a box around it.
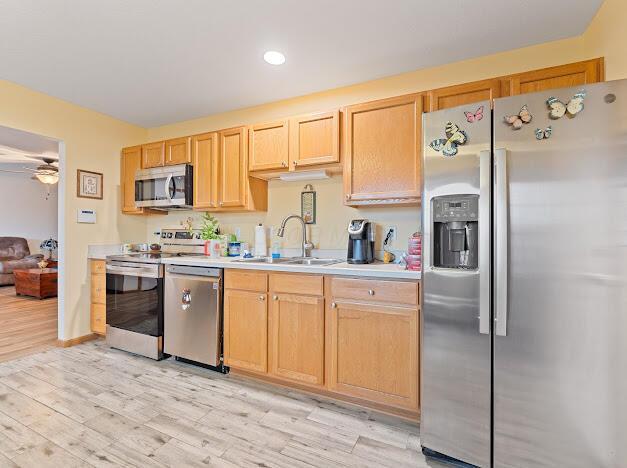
[146,176,420,254]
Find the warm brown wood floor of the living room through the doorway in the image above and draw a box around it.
[0,286,57,362]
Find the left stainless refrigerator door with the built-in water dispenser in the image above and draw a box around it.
[420,102,492,466]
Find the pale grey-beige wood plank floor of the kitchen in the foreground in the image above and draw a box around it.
[0,340,442,468]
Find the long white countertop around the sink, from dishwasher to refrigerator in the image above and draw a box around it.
[163,257,420,280]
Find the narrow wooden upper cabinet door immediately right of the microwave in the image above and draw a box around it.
[192,132,218,209]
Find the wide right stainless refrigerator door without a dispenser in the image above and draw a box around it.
[494,81,627,468]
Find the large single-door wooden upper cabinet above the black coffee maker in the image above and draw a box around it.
[344,94,422,205]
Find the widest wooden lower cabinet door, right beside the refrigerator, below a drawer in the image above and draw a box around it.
[327,301,419,410]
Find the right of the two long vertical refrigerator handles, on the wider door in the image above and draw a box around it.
[494,148,509,336]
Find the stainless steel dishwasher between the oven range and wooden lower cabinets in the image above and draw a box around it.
[163,265,225,372]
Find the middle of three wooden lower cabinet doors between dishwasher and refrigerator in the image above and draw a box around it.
[270,293,324,386]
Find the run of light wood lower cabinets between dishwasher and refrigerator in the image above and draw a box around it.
[224,270,420,419]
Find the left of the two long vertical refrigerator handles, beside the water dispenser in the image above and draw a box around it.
[479,150,492,335]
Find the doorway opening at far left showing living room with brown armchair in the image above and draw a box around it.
[0,126,64,362]
